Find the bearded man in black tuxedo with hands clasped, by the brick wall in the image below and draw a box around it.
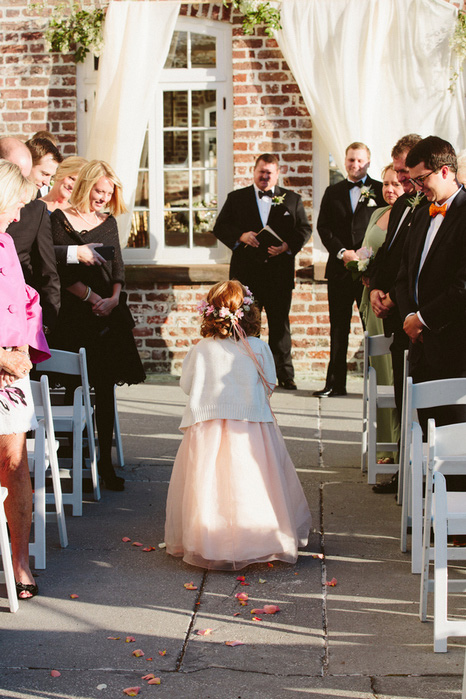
[314,142,384,398]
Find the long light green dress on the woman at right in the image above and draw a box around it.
[360,206,400,459]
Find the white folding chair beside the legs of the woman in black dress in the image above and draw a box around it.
[38,347,100,516]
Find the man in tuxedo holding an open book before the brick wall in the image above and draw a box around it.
[213,153,311,390]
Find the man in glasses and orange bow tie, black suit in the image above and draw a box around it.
[395,136,466,429]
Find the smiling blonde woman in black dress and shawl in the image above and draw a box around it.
[50,160,145,490]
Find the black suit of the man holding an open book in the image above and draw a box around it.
[214,185,311,381]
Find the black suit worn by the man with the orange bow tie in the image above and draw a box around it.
[396,183,466,425]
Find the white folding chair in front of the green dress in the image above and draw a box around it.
[361,330,398,483]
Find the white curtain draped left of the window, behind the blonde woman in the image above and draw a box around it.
[86,0,181,245]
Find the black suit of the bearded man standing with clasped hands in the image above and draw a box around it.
[317,176,385,392]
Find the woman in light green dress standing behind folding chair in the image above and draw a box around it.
[360,163,403,463]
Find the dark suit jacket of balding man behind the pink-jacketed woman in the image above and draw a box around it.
[8,199,60,329]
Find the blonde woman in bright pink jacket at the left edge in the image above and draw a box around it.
[0,160,50,599]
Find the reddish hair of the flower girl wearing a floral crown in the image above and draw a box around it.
[201,279,261,338]
